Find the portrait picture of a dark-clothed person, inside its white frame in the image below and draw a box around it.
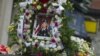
[34,15,52,37]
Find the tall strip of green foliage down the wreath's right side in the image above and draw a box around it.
[60,0,78,56]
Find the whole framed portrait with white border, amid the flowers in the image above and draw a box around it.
[32,13,53,39]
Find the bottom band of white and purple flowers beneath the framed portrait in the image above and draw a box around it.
[16,38,63,56]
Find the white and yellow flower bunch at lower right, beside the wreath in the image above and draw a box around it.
[71,36,95,56]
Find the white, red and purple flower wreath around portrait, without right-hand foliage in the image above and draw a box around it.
[9,0,68,56]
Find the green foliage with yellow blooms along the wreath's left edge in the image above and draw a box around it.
[8,0,24,47]
